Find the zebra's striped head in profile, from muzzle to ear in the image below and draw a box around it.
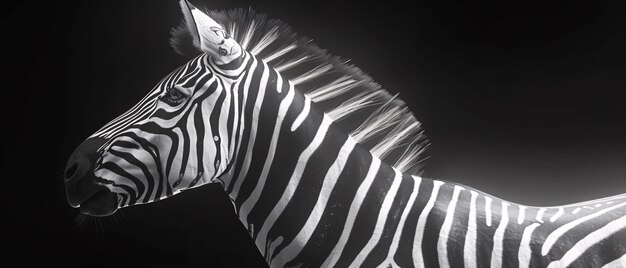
[65,0,241,216]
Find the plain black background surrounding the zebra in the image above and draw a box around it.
[0,0,626,267]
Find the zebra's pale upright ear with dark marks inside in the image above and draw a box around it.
[180,0,243,63]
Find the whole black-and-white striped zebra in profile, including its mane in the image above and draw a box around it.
[65,0,626,267]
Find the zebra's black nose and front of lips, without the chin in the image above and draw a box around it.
[64,138,106,208]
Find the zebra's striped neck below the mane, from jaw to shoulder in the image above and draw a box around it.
[212,54,432,266]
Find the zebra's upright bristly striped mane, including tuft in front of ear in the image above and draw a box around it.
[170,9,429,175]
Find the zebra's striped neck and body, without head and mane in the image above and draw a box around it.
[201,53,626,267]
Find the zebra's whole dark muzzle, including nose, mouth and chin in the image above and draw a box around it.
[64,138,118,216]
